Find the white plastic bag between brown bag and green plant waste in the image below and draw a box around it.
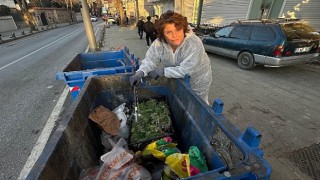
[112,103,129,139]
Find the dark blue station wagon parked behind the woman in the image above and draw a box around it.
[201,19,320,70]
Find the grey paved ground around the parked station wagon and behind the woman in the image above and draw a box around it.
[105,26,320,180]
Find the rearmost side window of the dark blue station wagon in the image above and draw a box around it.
[251,26,275,41]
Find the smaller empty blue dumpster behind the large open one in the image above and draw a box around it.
[56,47,139,99]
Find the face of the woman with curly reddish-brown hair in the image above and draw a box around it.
[163,23,184,49]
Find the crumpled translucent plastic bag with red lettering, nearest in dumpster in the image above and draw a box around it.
[97,138,151,180]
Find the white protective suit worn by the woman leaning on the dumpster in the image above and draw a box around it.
[138,33,212,104]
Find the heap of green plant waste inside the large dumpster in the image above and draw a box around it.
[130,99,172,143]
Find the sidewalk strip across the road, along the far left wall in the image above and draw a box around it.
[0,23,70,44]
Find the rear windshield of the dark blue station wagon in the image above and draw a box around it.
[281,23,317,40]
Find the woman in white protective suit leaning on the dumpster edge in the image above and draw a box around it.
[129,11,212,104]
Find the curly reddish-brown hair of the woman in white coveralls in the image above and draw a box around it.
[156,10,189,43]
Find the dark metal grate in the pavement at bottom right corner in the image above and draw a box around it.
[289,144,320,180]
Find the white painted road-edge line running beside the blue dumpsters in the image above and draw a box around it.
[18,28,99,180]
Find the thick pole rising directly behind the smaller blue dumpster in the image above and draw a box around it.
[81,0,97,52]
